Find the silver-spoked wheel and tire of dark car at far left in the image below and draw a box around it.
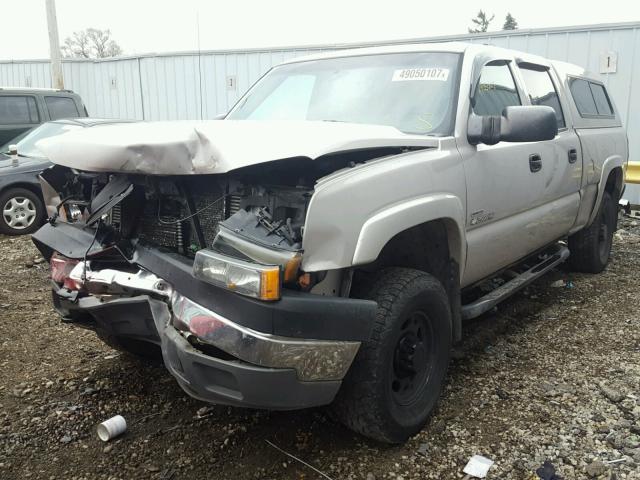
[0,188,46,235]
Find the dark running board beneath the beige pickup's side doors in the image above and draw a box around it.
[462,244,569,320]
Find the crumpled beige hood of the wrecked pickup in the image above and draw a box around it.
[37,120,438,175]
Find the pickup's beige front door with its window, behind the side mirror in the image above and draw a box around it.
[460,59,577,286]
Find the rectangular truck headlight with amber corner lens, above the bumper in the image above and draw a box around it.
[193,249,281,300]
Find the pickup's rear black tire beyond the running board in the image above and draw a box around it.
[568,192,618,273]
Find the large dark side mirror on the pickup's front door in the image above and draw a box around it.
[467,105,558,145]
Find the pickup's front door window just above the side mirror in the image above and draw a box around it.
[472,62,522,116]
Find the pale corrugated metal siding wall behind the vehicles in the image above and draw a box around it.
[0,22,640,199]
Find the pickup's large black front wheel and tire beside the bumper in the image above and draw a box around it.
[333,268,452,443]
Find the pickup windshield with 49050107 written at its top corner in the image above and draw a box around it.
[226,52,459,135]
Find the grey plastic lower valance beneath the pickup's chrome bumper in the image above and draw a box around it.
[69,295,341,410]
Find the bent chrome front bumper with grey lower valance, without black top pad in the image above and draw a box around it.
[54,262,360,409]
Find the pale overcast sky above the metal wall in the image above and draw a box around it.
[0,0,640,59]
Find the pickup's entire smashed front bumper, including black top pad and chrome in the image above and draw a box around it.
[33,222,377,410]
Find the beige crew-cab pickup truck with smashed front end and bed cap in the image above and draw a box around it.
[33,43,628,443]
